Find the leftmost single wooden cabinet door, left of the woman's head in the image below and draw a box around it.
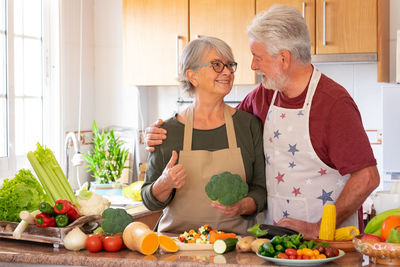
[123,0,189,85]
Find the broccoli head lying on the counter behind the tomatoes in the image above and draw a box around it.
[101,208,133,234]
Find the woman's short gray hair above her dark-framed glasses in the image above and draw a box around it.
[178,36,235,96]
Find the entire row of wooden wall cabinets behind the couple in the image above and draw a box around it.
[123,0,389,86]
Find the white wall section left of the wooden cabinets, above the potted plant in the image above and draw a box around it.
[94,0,138,128]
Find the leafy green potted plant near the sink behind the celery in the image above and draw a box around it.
[83,121,129,184]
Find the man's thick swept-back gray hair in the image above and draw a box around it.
[247,5,311,64]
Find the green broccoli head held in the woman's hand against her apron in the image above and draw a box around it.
[205,172,249,206]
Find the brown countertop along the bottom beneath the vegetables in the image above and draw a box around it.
[0,238,372,267]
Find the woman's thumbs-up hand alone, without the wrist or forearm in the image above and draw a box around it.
[162,150,186,189]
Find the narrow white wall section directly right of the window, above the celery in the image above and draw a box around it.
[60,0,95,137]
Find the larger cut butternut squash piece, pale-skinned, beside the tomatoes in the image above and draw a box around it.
[122,222,160,255]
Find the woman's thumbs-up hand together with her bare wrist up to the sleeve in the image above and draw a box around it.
[152,151,186,202]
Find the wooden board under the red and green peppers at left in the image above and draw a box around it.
[0,215,102,245]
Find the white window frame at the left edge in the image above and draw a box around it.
[0,0,62,180]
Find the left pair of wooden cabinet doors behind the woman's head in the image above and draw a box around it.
[123,0,256,85]
